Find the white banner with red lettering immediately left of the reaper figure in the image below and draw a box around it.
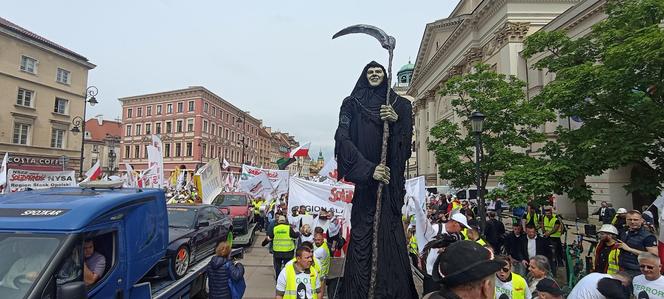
[288,177,355,224]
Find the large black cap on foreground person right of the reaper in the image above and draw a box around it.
[432,240,505,287]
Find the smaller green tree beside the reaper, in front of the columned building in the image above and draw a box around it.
[428,64,555,204]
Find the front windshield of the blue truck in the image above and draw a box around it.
[0,236,64,298]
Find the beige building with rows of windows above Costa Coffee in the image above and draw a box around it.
[0,18,95,170]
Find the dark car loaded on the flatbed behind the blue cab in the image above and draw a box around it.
[150,205,233,279]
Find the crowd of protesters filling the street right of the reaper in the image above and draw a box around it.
[402,194,664,299]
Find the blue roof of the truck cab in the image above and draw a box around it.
[0,187,165,232]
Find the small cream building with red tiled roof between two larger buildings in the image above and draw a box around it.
[83,115,123,176]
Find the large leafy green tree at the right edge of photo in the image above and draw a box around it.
[520,0,664,201]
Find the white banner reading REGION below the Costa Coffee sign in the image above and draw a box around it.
[7,169,76,192]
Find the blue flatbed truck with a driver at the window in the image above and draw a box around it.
[0,187,233,299]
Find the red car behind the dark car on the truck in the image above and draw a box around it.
[212,192,254,234]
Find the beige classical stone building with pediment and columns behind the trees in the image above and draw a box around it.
[408,0,640,218]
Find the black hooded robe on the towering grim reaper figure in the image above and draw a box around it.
[334,61,418,299]
